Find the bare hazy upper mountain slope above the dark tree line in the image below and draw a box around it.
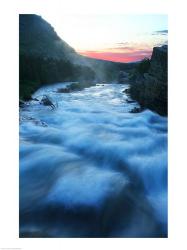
[19,14,76,60]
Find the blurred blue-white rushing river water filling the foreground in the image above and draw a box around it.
[20,83,167,237]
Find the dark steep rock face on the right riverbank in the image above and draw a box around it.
[130,45,168,116]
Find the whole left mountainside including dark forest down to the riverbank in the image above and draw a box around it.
[19,14,135,100]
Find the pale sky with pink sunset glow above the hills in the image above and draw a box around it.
[41,13,168,62]
